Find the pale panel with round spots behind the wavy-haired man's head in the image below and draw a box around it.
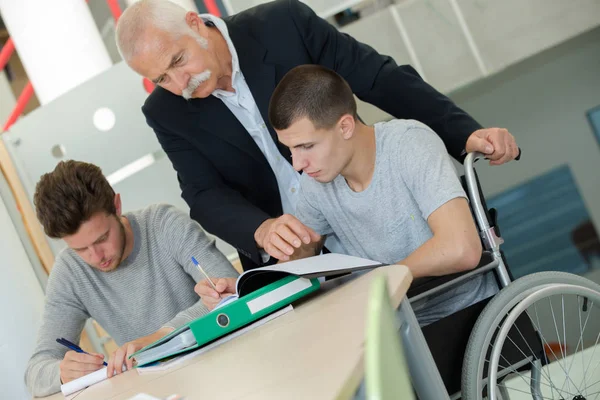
[0,62,237,259]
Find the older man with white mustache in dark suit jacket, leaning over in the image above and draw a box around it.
[117,0,518,269]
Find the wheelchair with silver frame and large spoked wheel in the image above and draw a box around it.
[399,153,600,400]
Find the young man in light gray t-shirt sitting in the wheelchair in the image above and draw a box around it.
[269,65,497,325]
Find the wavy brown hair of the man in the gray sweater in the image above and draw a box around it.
[33,160,117,238]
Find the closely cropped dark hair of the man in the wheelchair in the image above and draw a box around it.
[269,65,356,130]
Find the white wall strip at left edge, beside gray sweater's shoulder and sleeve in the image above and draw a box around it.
[0,180,44,400]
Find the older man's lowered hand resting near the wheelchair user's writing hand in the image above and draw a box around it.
[254,214,321,261]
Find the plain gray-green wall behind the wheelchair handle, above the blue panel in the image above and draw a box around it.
[450,29,600,241]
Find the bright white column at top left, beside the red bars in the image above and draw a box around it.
[0,0,112,105]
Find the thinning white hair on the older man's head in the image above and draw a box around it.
[115,0,208,63]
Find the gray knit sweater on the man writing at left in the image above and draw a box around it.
[25,204,238,396]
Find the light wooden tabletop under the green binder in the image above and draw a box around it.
[38,265,412,400]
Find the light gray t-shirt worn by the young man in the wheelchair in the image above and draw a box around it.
[296,120,498,325]
